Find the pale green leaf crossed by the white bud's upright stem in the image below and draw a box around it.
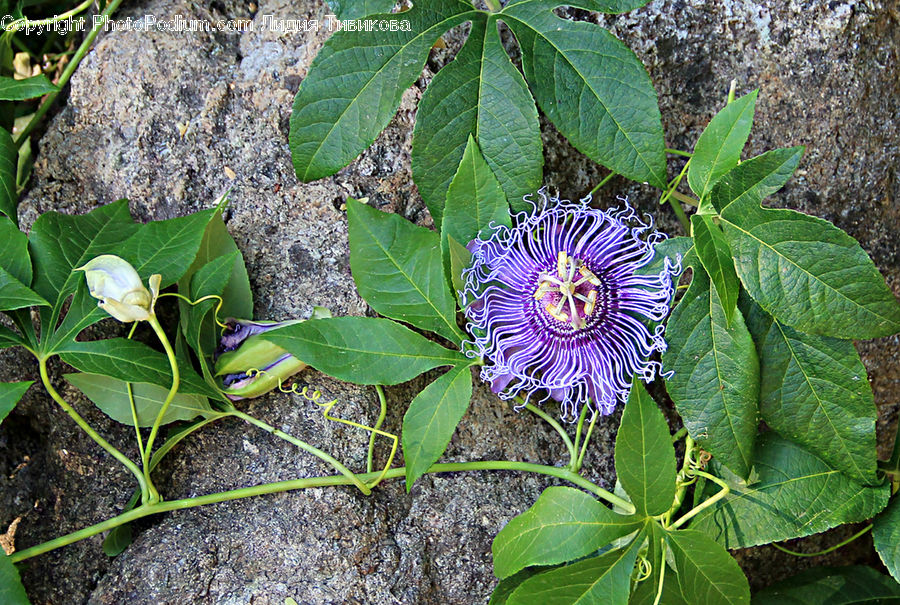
[65,374,212,427]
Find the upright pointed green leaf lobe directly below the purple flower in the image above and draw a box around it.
[615,378,676,517]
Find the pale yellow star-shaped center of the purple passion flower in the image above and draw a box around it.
[534,252,602,330]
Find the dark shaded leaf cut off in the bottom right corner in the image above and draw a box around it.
[753,565,900,605]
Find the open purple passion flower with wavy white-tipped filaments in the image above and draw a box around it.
[463,190,677,418]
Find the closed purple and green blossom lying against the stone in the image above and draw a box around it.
[215,319,306,401]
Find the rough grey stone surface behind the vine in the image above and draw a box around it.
[0,0,900,604]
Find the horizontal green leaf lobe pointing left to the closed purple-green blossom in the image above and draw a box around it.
[266,317,468,385]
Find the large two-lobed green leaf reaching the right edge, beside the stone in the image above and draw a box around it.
[711,148,900,339]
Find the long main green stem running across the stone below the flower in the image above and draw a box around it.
[9,460,634,563]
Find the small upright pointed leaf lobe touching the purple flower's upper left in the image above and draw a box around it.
[441,135,511,246]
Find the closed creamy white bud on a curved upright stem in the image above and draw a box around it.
[75,254,162,323]
